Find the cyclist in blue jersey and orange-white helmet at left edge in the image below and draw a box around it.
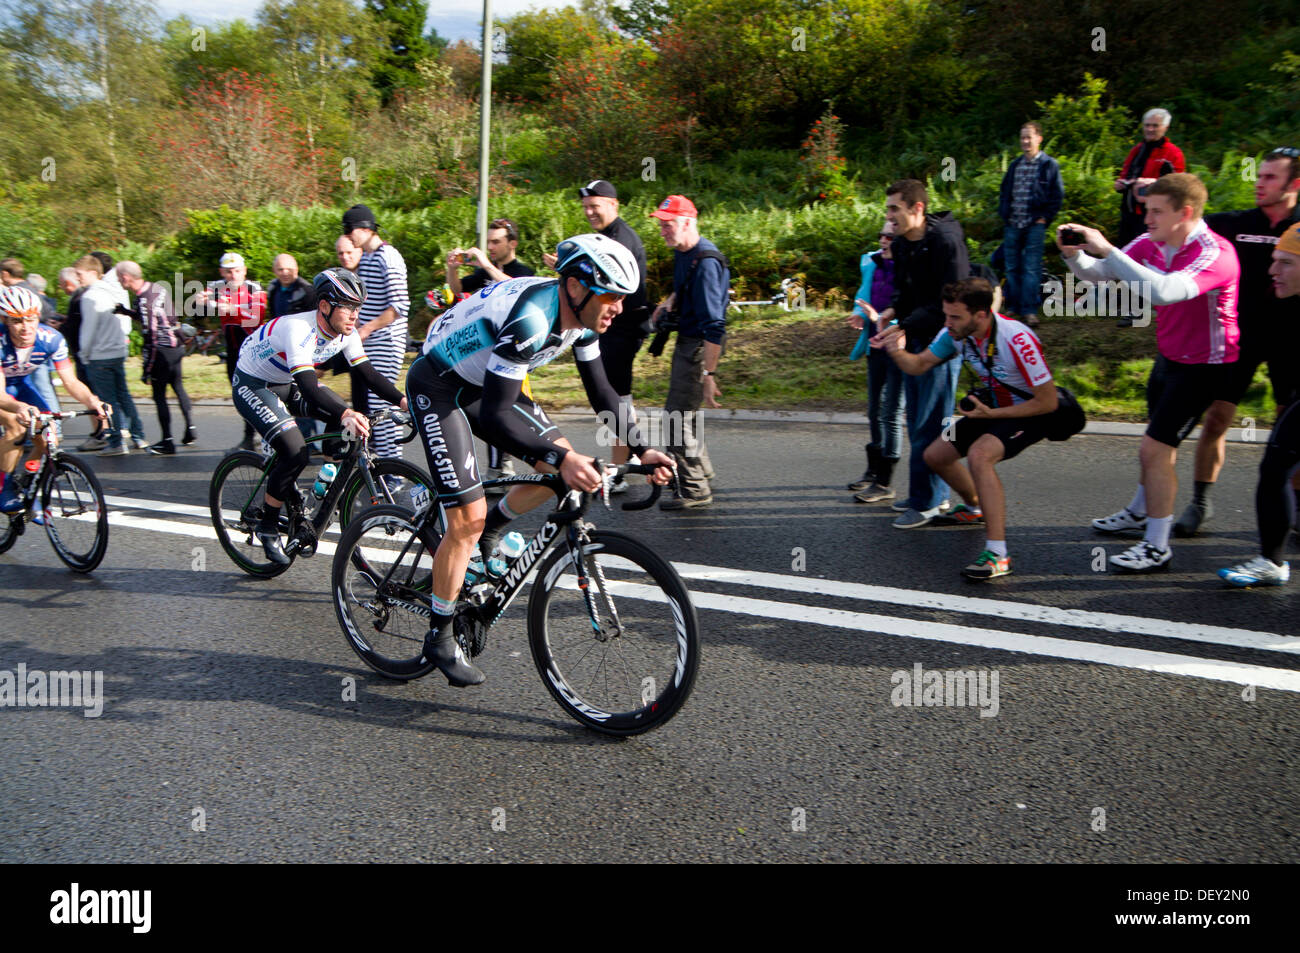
[0,285,109,512]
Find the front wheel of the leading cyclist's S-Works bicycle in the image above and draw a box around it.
[528,530,699,735]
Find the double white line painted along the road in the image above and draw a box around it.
[83,498,1300,692]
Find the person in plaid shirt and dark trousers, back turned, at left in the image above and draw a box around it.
[117,261,195,456]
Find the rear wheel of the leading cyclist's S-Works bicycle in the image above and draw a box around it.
[330,506,441,681]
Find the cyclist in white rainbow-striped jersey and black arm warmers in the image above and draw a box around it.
[230,268,407,566]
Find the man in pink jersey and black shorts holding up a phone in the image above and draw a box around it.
[1057,173,1242,572]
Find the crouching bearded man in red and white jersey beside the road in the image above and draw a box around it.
[871,278,1057,579]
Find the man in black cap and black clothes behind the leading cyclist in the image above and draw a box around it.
[542,178,650,493]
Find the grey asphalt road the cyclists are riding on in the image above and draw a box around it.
[0,407,1300,862]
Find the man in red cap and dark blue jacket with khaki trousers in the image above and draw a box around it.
[650,195,731,510]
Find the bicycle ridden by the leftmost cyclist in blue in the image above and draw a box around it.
[0,411,108,572]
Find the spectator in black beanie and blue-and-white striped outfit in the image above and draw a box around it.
[343,205,411,458]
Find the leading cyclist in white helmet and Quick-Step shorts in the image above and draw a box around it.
[407,234,672,686]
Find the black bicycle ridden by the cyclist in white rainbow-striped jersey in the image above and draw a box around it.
[208,408,433,577]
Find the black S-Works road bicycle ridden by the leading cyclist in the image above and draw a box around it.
[332,463,699,736]
